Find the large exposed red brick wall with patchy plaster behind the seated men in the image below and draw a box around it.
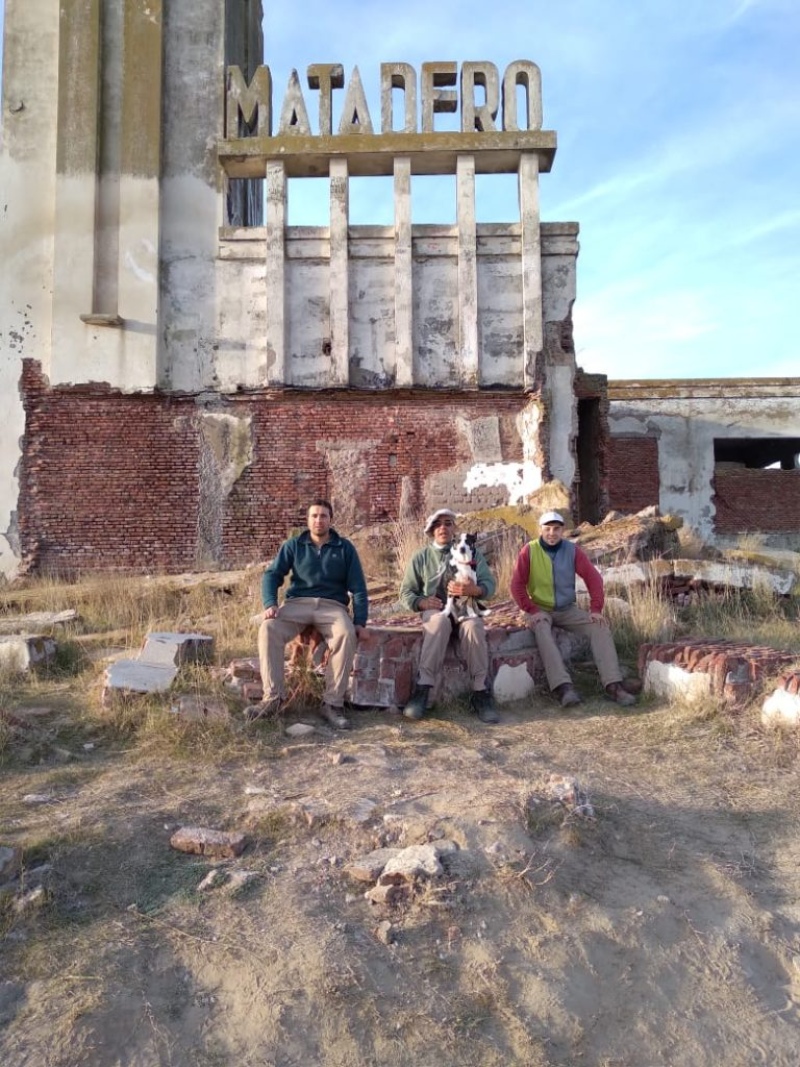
[18,360,538,573]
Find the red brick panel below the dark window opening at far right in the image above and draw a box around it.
[714,466,800,534]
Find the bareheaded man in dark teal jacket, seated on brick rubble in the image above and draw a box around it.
[244,500,369,730]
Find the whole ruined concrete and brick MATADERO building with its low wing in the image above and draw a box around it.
[0,0,800,575]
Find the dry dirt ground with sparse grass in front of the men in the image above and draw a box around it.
[0,675,800,1067]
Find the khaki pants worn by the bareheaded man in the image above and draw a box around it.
[258,596,358,707]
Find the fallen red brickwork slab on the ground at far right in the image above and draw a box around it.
[639,638,798,706]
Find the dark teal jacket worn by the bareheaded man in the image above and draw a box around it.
[261,527,369,626]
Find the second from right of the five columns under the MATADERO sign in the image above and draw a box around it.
[455,156,480,388]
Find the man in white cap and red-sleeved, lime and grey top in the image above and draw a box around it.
[511,511,636,707]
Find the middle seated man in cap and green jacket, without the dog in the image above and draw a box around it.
[400,508,500,722]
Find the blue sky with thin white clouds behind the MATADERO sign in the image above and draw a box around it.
[0,0,800,378]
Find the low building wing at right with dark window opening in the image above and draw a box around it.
[608,378,800,542]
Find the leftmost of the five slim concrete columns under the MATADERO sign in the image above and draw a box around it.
[266,161,291,385]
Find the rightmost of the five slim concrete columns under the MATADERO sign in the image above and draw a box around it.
[518,152,544,389]
